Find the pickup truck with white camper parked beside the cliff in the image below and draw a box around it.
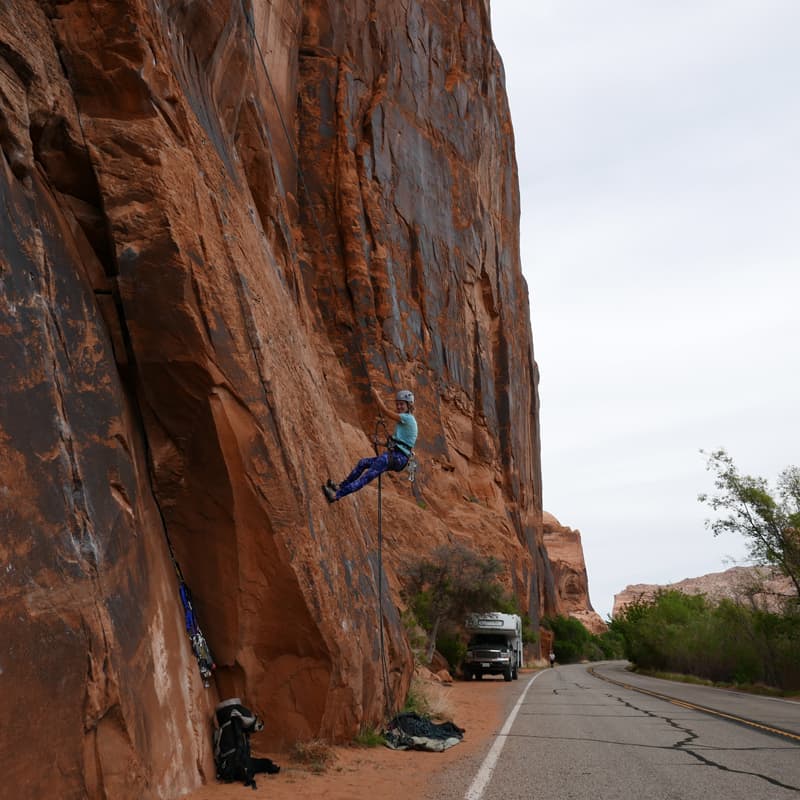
[461,611,522,681]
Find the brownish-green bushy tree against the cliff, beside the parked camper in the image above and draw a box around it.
[403,544,505,663]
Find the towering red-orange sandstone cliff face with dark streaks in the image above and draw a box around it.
[0,0,557,798]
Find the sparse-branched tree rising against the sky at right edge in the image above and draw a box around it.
[698,450,800,595]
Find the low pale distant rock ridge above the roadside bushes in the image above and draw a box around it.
[611,567,794,617]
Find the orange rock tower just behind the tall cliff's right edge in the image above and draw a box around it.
[542,511,608,634]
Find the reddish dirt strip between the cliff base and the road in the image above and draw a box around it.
[183,675,522,800]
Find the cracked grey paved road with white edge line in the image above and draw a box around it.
[433,663,800,800]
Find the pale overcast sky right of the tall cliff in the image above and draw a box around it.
[491,0,800,617]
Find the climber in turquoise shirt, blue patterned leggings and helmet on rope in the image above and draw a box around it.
[322,388,417,503]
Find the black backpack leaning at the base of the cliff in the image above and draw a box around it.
[214,697,280,789]
